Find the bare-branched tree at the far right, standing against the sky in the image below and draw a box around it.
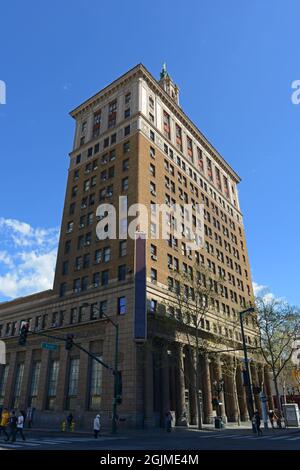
[255,298,300,413]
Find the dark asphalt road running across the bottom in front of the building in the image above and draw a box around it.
[0,429,300,451]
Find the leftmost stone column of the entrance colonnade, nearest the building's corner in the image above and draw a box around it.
[144,340,154,428]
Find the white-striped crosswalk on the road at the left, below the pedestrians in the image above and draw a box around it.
[0,436,124,450]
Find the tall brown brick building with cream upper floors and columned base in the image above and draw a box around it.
[0,64,269,428]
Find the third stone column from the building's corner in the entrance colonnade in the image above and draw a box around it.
[176,343,187,426]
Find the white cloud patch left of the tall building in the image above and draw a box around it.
[0,218,59,301]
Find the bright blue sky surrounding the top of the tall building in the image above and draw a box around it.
[0,0,300,305]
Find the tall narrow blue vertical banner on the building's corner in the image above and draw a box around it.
[134,232,147,341]
